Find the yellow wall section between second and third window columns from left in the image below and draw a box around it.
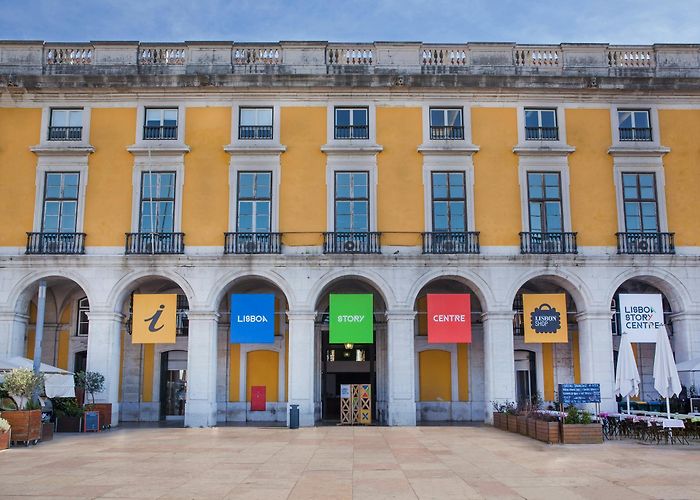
[182,107,230,246]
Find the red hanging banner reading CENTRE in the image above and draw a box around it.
[428,293,472,344]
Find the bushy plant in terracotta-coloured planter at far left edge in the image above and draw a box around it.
[0,368,44,445]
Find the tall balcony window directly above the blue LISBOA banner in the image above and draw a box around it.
[236,172,272,233]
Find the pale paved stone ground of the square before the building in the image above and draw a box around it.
[0,426,700,500]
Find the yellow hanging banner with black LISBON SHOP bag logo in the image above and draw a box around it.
[523,293,569,344]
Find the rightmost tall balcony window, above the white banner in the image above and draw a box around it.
[622,173,659,233]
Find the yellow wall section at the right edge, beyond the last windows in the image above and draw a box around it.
[652,109,700,245]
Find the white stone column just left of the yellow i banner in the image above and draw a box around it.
[87,311,124,426]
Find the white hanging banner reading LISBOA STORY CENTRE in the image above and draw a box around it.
[620,293,664,342]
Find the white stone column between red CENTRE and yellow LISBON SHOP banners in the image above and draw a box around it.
[481,310,515,423]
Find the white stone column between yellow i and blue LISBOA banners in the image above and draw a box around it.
[185,310,219,427]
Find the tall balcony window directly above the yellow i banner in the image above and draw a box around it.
[139,172,175,233]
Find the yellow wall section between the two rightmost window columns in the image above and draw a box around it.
[566,109,617,246]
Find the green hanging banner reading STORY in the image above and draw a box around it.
[329,293,374,344]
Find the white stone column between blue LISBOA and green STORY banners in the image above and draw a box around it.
[287,311,316,427]
